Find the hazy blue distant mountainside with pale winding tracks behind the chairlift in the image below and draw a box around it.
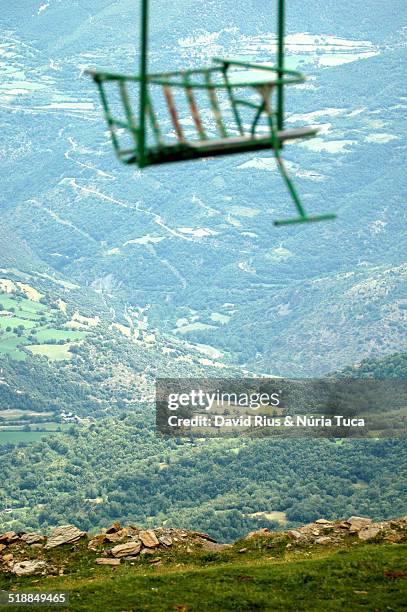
[0,0,406,375]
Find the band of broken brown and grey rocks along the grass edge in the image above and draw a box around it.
[0,516,407,576]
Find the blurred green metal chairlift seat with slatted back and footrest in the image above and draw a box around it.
[87,0,336,225]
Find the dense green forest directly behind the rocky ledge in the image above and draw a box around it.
[0,354,407,538]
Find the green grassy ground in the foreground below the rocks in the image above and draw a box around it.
[0,541,407,612]
